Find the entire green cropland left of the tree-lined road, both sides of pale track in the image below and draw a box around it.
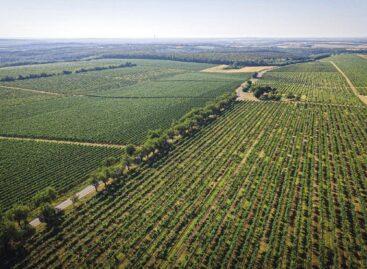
[0,59,249,210]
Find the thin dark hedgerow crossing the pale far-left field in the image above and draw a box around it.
[0,62,136,82]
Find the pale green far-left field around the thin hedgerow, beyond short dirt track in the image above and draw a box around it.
[0,59,224,95]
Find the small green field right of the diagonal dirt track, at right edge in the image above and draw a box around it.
[327,54,367,96]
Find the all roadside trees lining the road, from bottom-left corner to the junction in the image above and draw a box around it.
[0,90,236,259]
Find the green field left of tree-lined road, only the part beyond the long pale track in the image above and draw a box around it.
[0,59,250,144]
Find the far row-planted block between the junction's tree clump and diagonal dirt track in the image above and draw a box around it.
[259,58,361,105]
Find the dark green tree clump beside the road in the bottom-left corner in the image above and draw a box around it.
[0,187,62,257]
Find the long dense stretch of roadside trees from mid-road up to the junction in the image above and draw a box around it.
[89,94,236,191]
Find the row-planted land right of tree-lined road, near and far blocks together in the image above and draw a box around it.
[3,56,367,268]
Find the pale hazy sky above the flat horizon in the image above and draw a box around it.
[0,0,367,38]
